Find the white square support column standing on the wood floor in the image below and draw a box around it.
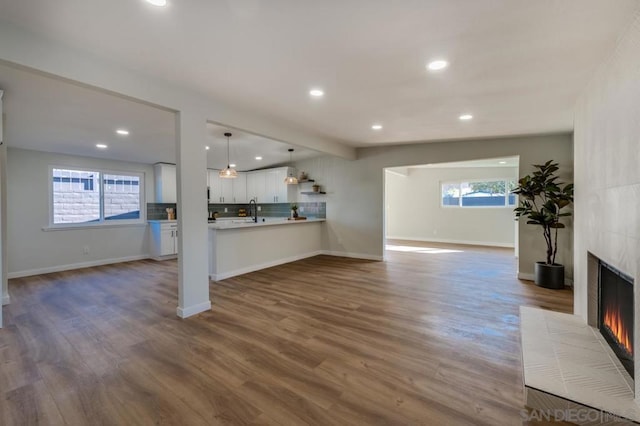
[176,111,211,318]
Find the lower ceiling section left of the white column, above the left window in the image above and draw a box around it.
[0,64,175,163]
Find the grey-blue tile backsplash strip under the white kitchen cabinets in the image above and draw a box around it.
[147,202,327,220]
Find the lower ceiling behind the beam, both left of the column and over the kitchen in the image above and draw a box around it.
[0,64,319,171]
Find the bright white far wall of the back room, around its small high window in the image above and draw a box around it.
[385,167,518,247]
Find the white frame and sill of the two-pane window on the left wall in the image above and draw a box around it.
[48,165,147,231]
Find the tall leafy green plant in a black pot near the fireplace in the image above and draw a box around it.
[511,160,573,289]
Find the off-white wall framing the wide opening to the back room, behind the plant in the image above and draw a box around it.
[296,135,573,278]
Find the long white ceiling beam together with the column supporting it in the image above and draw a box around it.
[0,23,355,317]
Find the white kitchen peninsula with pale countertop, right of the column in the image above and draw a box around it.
[209,218,325,281]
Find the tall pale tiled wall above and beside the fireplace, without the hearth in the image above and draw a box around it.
[574,18,640,320]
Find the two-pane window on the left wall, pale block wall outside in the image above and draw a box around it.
[50,167,144,225]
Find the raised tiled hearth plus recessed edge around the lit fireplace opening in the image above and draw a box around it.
[521,253,640,425]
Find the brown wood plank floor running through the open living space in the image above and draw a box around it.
[0,241,573,425]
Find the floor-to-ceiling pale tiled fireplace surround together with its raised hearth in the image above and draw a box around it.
[521,12,640,424]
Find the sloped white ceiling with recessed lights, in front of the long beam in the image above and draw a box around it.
[0,0,640,153]
